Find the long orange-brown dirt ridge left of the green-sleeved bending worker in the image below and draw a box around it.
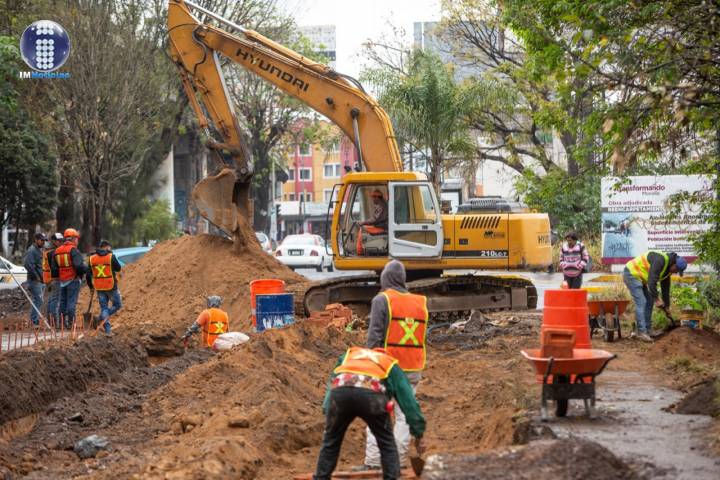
[86,322,364,479]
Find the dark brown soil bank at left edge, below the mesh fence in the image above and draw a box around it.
[0,338,147,424]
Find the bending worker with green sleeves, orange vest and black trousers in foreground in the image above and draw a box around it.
[313,347,425,480]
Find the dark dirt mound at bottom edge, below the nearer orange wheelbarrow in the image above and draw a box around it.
[423,438,637,480]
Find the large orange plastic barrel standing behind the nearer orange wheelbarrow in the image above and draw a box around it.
[541,289,592,348]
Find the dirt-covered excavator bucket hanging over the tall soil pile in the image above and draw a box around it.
[192,168,252,244]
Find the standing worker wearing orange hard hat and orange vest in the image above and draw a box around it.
[51,228,86,328]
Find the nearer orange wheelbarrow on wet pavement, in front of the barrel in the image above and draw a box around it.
[520,348,617,421]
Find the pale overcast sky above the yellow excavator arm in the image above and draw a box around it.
[281,0,440,77]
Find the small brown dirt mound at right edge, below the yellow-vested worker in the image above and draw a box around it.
[649,327,720,364]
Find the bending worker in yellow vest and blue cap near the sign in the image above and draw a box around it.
[623,250,687,342]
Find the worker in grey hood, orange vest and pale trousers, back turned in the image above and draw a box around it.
[355,260,428,470]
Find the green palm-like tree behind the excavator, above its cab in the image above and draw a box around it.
[364,50,476,193]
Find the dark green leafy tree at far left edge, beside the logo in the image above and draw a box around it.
[0,37,57,255]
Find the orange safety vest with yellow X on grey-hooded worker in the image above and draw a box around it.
[382,289,429,372]
